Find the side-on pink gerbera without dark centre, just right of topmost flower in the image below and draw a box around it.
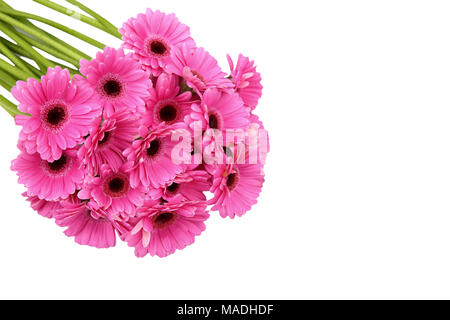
[166,46,234,93]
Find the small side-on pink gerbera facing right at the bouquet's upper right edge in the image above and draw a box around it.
[227,54,263,111]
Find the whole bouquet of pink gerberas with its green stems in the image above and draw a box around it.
[0,0,269,257]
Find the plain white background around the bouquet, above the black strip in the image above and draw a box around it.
[0,0,450,299]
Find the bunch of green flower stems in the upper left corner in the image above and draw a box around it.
[0,0,121,116]
